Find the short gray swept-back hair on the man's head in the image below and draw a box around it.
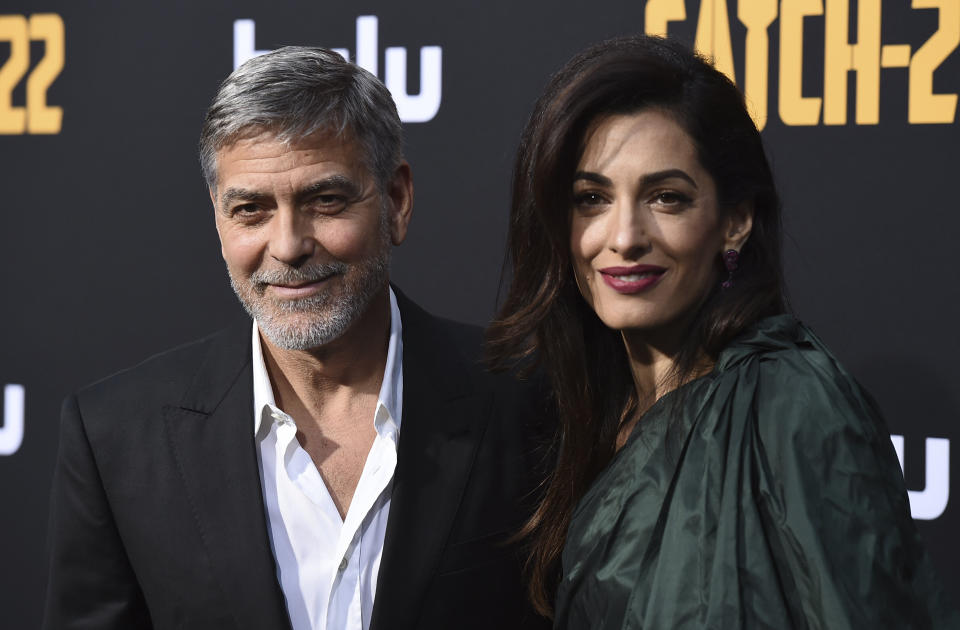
[200,46,403,190]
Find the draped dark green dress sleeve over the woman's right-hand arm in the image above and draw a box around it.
[715,315,958,628]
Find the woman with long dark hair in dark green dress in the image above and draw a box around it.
[488,37,960,629]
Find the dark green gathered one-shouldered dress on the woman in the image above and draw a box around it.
[555,315,960,630]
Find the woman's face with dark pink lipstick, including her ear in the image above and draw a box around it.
[570,110,752,340]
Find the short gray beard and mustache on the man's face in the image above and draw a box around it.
[227,247,390,350]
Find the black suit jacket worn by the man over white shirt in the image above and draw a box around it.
[44,295,545,630]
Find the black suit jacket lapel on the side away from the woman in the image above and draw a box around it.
[164,321,289,630]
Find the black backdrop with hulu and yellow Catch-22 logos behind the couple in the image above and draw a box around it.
[0,0,960,628]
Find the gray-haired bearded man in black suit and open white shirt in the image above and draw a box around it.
[45,48,543,630]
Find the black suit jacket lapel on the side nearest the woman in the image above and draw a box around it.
[370,289,492,630]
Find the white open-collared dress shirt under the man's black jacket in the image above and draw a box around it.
[253,289,403,630]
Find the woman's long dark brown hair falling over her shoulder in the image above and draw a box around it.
[487,36,784,615]
